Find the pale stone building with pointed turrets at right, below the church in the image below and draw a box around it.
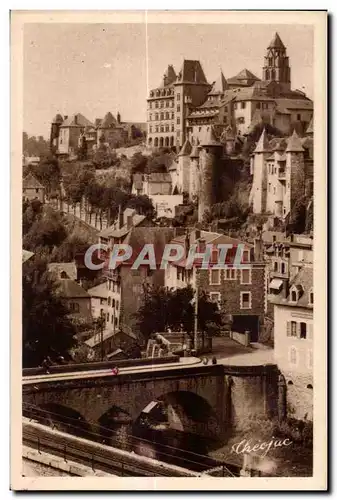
[250,129,313,219]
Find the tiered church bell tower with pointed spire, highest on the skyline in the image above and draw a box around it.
[263,33,291,92]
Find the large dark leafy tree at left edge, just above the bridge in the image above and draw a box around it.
[22,262,76,367]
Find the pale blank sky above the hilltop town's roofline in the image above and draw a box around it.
[23,23,314,139]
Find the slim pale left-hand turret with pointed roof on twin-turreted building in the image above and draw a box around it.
[249,129,270,214]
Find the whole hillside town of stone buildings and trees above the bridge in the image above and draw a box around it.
[22,33,314,476]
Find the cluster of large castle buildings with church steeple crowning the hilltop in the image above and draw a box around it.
[147,33,313,150]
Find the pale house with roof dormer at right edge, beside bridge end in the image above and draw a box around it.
[274,264,314,420]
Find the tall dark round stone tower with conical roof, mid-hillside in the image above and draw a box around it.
[198,126,223,222]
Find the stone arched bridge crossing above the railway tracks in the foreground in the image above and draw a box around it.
[23,365,278,446]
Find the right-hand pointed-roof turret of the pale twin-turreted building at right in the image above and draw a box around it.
[284,130,305,216]
